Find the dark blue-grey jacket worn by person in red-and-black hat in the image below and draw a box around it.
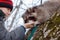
[0,11,25,40]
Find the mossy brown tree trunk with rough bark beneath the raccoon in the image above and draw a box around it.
[25,5,60,40]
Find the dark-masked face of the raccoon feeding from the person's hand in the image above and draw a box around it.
[22,7,37,22]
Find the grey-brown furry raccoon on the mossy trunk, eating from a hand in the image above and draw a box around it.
[23,0,60,23]
